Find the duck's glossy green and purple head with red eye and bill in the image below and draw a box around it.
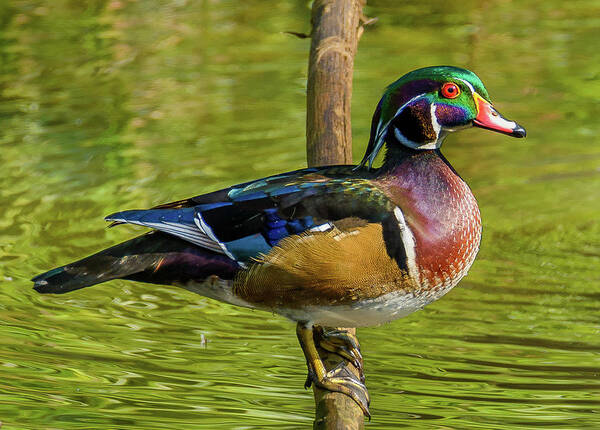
[361,66,525,167]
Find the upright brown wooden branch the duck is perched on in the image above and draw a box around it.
[306,0,366,430]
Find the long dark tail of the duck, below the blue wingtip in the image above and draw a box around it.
[32,231,239,294]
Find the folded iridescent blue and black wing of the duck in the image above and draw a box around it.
[106,166,393,264]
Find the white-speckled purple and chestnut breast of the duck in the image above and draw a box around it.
[380,153,481,298]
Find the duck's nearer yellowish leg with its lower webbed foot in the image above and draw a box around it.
[296,322,371,417]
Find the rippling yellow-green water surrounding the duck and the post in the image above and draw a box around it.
[0,0,600,430]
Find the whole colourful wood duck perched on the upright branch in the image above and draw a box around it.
[33,66,525,414]
